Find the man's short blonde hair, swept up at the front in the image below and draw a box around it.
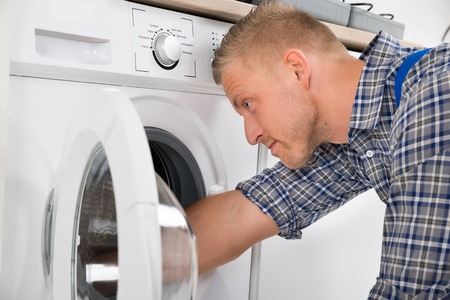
[212,1,348,84]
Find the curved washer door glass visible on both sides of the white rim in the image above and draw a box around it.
[72,146,197,299]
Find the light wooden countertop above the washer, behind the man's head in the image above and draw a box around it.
[134,0,417,51]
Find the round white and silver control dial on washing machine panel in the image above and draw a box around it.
[153,32,181,69]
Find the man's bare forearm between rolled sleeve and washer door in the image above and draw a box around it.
[186,190,279,274]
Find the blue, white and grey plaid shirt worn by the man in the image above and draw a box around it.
[237,32,450,300]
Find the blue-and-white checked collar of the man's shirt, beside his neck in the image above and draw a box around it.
[350,32,400,129]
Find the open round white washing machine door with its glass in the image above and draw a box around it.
[44,88,197,300]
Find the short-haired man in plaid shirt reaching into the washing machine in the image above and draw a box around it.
[187,2,450,299]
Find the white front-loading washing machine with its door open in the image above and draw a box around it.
[0,0,257,300]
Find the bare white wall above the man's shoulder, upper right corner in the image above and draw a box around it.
[366,0,450,47]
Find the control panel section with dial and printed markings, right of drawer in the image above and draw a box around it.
[130,3,232,86]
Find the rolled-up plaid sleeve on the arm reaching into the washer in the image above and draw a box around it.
[237,144,370,239]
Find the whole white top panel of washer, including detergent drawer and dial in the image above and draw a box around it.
[10,0,232,95]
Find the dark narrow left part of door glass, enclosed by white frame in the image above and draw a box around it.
[72,147,119,299]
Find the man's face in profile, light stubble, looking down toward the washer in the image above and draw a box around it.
[222,60,322,168]
